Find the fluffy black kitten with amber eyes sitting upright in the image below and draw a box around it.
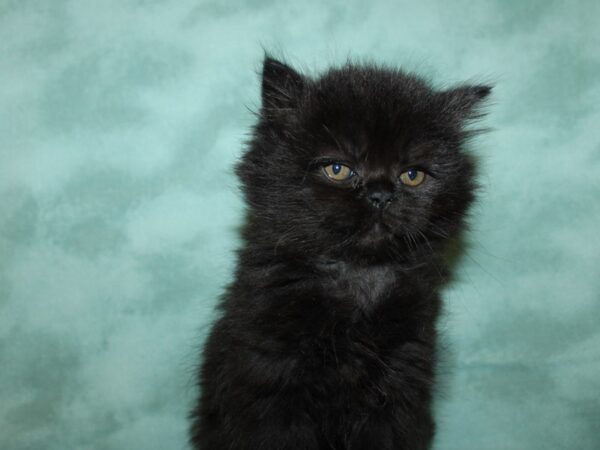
[191,58,490,450]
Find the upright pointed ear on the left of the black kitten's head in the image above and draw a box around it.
[262,56,305,109]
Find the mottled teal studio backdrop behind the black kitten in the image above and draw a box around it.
[0,0,600,450]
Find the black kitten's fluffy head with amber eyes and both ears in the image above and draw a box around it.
[238,57,491,266]
